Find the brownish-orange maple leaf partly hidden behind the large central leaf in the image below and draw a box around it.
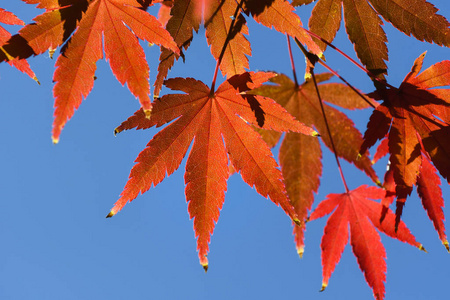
[249,73,379,256]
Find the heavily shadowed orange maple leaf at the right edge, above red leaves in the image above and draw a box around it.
[361,53,450,223]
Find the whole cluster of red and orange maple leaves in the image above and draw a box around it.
[0,0,450,299]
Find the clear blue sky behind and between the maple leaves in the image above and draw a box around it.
[0,0,450,300]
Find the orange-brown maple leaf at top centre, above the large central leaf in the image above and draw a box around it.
[155,0,322,95]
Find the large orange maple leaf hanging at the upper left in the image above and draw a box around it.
[20,0,179,143]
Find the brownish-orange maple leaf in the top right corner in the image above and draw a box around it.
[292,0,450,74]
